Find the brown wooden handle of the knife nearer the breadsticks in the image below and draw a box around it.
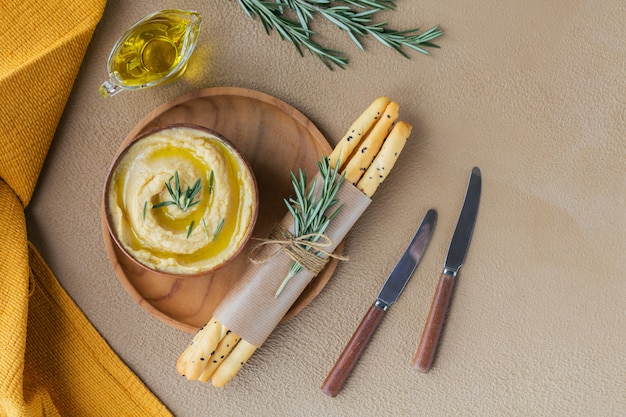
[322,304,385,397]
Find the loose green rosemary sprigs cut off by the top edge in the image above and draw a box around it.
[233,0,443,69]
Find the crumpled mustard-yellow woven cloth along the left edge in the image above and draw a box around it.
[0,0,171,417]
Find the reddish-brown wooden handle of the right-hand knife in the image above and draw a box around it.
[413,274,456,372]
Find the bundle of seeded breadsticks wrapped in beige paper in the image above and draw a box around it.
[176,97,412,387]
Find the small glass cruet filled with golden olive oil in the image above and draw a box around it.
[99,10,202,97]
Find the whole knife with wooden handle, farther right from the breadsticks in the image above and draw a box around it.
[413,167,482,372]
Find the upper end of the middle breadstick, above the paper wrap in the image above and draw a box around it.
[342,101,400,184]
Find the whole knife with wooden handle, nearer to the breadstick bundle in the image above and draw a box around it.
[322,209,437,397]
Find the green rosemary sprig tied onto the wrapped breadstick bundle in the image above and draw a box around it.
[275,157,345,297]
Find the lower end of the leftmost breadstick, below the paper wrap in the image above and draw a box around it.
[176,318,226,380]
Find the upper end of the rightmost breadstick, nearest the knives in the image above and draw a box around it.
[357,121,413,198]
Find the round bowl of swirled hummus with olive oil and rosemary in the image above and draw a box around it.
[104,125,258,276]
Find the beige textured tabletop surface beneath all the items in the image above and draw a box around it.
[28,0,626,417]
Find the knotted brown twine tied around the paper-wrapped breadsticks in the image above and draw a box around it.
[249,224,348,292]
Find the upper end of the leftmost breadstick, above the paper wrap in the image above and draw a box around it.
[328,97,391,171]
